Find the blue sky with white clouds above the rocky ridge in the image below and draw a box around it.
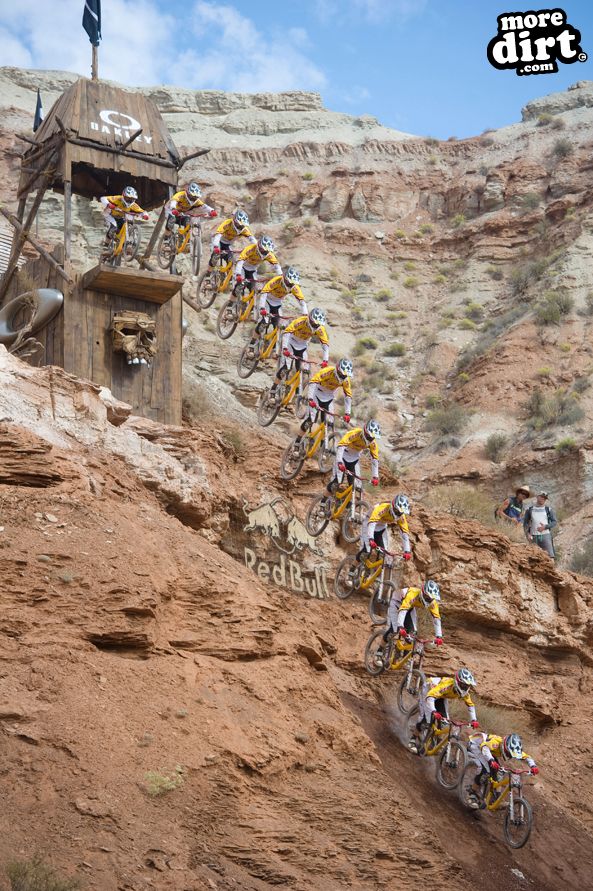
[0,0,593,139]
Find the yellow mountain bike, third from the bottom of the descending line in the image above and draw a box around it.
[364,628,432,715]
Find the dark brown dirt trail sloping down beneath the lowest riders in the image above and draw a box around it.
[343,694,593,891]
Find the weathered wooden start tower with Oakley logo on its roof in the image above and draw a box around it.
[0,78,204,424]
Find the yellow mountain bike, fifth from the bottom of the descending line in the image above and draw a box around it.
[305,471,371,544]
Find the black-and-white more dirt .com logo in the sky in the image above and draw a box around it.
[487,9,587,75]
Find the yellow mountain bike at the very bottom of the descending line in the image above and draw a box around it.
[459,760,533,848]
